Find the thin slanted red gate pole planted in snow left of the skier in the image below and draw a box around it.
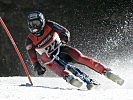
[0,17,33,85]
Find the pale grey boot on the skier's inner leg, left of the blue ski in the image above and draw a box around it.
[63,74,83,88]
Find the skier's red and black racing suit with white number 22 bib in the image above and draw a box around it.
[26,21,106,77]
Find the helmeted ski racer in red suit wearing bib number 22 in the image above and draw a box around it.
[26,11,110,85]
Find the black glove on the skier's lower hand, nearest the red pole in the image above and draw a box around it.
[33,62,46,75]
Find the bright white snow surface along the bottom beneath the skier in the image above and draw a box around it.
[0,77,133,100]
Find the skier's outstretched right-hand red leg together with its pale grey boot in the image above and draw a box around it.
[61,46,124,85]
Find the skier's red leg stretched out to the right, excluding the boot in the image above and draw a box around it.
[61,46,106,73]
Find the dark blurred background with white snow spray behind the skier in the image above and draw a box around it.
[0,0,133,76]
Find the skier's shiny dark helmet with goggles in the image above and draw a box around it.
[28,11,45,36]
